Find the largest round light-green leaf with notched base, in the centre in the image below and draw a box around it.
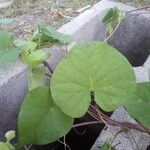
[50,42,136,118]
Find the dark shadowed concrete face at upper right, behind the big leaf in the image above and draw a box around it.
[108,11,150,67]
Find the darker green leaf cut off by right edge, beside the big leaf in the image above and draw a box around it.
[125,83,150,127]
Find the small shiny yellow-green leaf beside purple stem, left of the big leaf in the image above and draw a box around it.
[21,50,50,67]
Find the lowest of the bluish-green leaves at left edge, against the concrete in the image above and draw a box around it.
[0,48,20,68]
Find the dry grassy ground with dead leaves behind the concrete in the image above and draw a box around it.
[0,0,150,38]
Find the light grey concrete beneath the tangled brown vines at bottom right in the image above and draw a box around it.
[91,107,150,150]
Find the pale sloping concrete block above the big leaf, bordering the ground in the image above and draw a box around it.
[58,0,134,41]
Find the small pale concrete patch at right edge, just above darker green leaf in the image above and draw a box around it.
[133,66,150,83]
